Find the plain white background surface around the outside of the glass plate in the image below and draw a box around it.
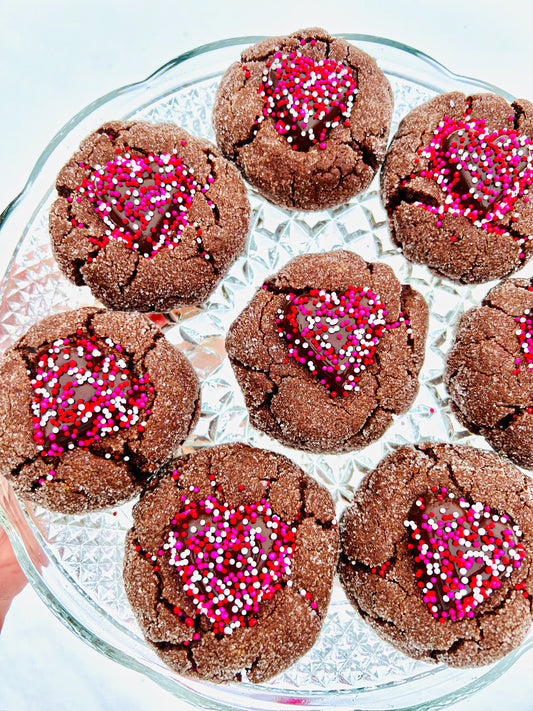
[0,0,533,711]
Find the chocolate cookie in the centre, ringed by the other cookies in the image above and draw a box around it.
[226,251,428,452]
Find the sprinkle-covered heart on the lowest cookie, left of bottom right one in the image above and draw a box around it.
[159,487,298,634]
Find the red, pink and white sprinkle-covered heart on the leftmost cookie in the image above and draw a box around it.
[28,329,154,483]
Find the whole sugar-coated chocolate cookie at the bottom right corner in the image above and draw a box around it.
[339,442,533,667]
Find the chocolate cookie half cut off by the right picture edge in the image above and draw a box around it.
[444,279,533,469]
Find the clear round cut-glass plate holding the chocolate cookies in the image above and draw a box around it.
[0,35,533,711]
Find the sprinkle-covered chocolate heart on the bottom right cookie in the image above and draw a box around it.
[404,487,525,622]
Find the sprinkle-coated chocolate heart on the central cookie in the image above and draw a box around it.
[276,286,410,397]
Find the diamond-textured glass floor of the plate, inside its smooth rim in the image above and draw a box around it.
[0,51,528,708]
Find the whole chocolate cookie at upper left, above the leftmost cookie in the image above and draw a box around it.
[50,121,250,311]
